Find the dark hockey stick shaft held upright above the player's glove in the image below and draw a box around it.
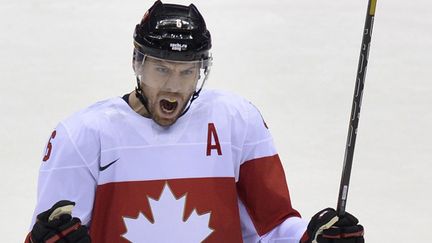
[336,0,377,216]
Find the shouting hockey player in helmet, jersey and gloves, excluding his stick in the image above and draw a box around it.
[26,1,363,243]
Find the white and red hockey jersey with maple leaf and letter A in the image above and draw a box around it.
[33,90,306,243]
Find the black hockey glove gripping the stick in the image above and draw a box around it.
[300,208,364,243]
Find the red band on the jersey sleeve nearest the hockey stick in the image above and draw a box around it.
[237,154,300,235]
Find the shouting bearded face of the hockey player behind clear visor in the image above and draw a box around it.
[137,56,199,126]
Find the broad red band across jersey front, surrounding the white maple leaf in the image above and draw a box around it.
[90,177,242,243]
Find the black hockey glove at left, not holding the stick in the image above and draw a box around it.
[28,200,91,243]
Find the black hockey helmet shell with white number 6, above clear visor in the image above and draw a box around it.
[134,0,211,61]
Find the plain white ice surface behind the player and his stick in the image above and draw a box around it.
[0,0,432,243]
